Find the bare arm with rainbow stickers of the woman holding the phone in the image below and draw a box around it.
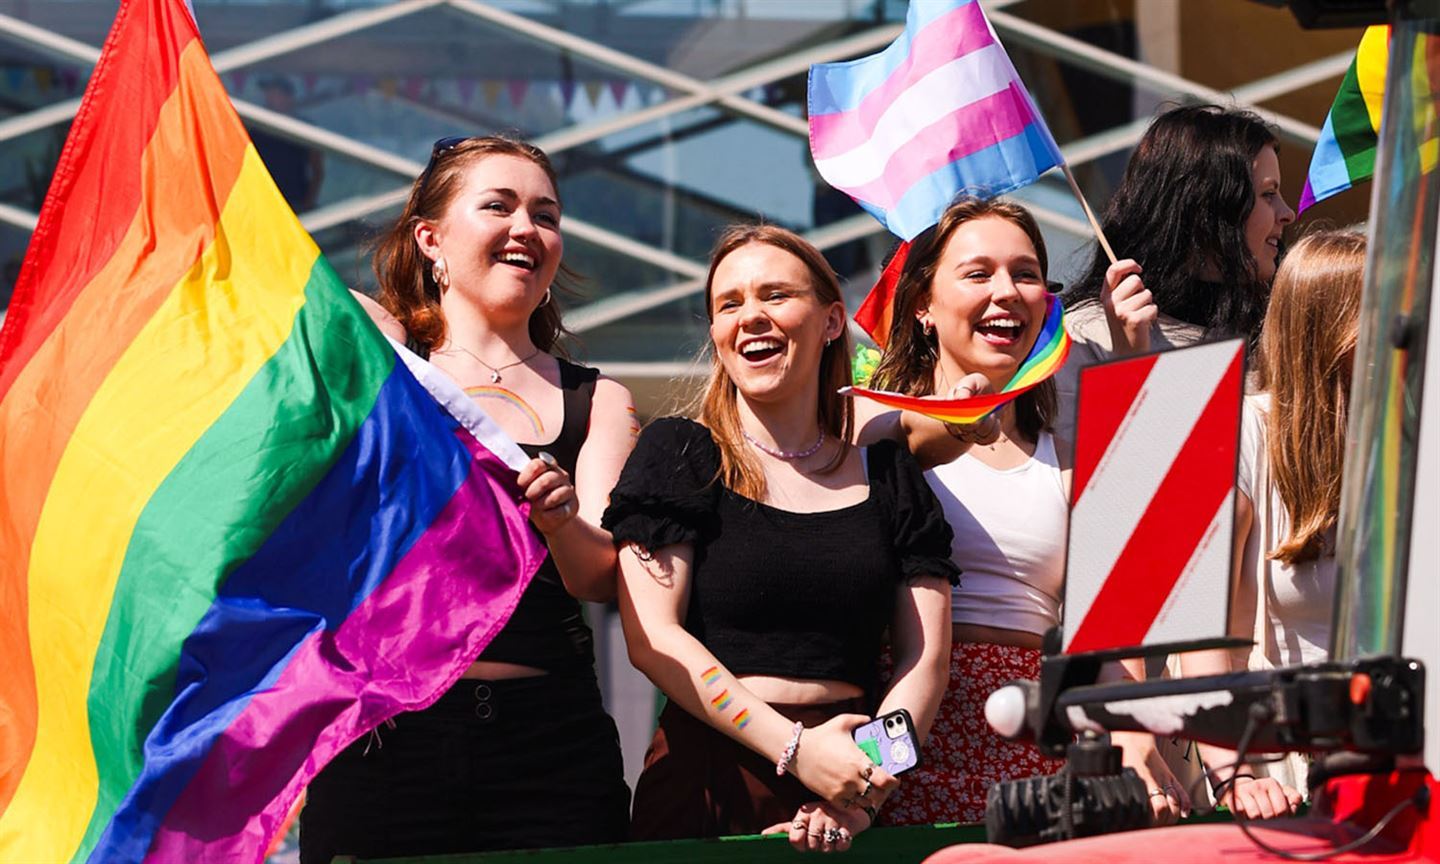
[619,543,887,806]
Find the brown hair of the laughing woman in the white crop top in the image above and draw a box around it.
[870,196,1058,441]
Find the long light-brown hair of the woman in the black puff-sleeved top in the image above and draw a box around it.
[693,225,855,501]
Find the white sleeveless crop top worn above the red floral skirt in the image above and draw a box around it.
[924,432,1068,634]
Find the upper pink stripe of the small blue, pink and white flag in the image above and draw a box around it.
[809,3,995,158]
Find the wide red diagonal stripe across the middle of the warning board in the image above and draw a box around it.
[1066,353,1243,654]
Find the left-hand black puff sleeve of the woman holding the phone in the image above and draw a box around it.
[600,418,720,550]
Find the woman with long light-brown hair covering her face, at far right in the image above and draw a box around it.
[1182,230,1365,818]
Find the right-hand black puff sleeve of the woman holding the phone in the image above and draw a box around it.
[870,441,960,585]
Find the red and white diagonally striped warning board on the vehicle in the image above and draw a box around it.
[1064,340,1244,654]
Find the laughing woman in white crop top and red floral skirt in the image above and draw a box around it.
[857,199,1181,825]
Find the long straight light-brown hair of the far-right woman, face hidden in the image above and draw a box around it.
[1257,229,1365,564]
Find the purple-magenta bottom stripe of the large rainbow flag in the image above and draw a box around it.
[145,432,544,864]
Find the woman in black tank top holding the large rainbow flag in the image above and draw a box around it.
[300,137,634,861]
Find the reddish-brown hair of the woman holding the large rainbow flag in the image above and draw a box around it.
[372,135,576,354]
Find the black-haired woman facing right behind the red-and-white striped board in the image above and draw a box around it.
[1056,105,1295,439]
